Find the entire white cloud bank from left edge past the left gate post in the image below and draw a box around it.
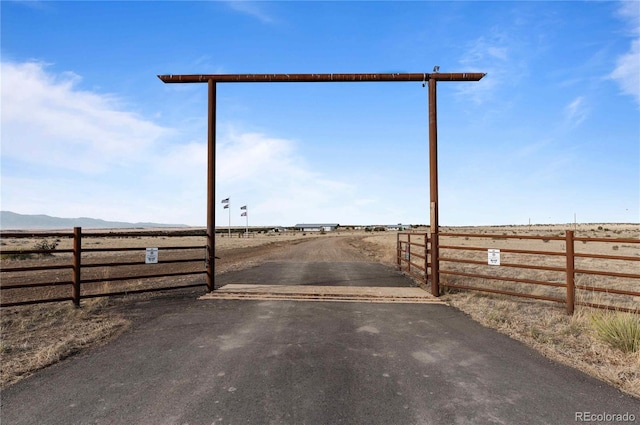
[1,62,396,225]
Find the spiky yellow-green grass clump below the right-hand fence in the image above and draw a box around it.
[591,311,640,353]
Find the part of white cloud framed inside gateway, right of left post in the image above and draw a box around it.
[216,129,380,225]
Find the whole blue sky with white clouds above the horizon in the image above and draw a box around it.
[0,0,640,226]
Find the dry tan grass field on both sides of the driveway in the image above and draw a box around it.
[0,224,640,397]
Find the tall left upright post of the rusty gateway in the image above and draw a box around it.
[207,80,216,292]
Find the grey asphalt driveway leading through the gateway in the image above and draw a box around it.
[0,262,640,425]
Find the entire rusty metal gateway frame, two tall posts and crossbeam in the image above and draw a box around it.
[158,73,486,295]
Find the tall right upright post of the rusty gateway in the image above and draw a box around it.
[429,79,440,296]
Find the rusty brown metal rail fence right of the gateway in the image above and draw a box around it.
[397,230,640,314]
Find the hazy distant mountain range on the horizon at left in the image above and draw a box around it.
[0,211,188,230]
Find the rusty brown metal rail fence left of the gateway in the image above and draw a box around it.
[0,227,208,307]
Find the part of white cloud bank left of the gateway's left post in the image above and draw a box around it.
[0,62,206,224]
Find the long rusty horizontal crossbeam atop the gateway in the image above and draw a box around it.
[158,72,486,83]
